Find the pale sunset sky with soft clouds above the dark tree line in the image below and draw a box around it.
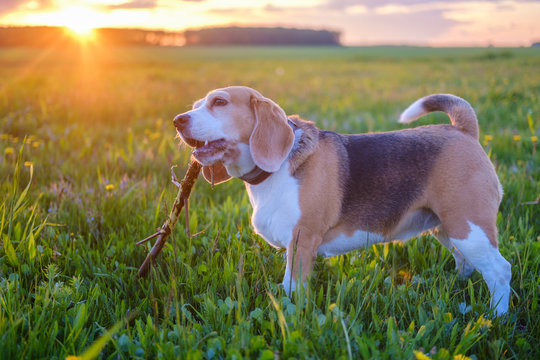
[0,0,540,46]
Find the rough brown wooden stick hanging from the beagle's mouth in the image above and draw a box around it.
[137,161,202,277]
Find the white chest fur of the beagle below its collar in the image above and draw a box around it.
[246,161,300,248]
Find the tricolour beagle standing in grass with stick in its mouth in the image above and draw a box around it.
[174,86,511,315]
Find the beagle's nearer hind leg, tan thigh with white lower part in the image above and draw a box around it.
[426,137,512,315]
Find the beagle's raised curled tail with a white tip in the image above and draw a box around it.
[399,94,478,139]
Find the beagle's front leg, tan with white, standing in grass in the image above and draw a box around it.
[281,226,322,296]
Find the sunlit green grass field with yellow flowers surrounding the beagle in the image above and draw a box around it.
[0,48,540,359]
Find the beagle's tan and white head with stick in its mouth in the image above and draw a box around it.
[174,86,294,184]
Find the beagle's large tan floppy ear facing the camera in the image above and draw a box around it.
[249,95,294,172]
